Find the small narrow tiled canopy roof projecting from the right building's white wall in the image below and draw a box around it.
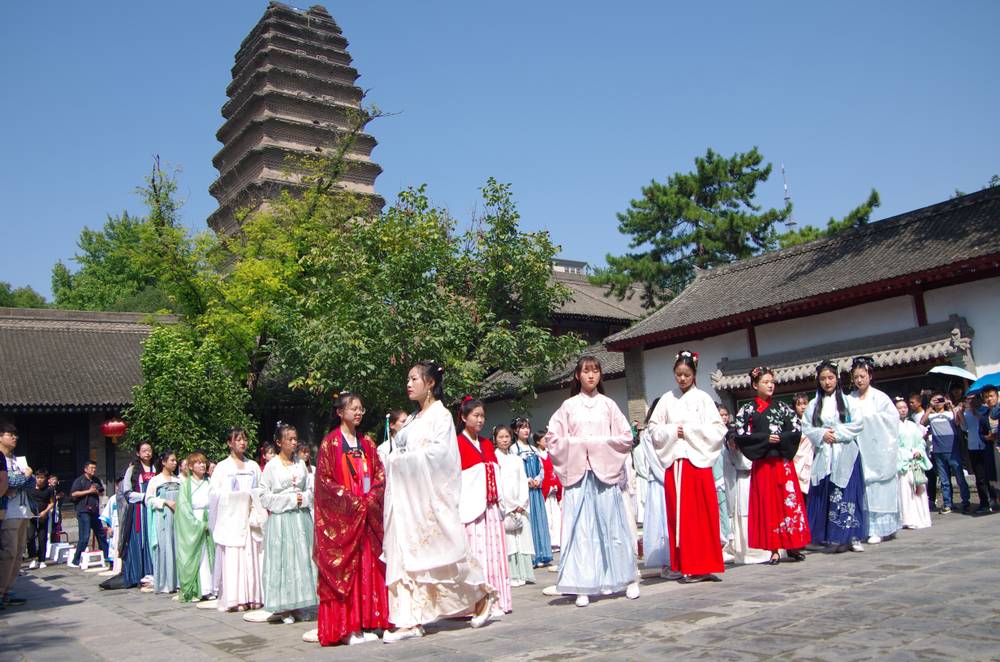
[711,315,973,391]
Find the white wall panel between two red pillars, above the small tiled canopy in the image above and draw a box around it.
[756,296,916,358]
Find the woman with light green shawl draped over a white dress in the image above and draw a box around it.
[174,453,215,606]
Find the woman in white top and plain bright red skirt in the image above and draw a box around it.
[649,350,726,582]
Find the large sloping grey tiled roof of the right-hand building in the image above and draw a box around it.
[606,187,1000,350]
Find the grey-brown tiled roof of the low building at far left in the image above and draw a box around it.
[0,308,172,409]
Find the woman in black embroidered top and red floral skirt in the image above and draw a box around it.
[736,366,810,565]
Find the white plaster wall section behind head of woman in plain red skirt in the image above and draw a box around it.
[643,331,750,403]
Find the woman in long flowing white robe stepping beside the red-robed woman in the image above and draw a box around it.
[383,361,495,643]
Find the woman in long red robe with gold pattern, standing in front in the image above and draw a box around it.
[302,393,390,646]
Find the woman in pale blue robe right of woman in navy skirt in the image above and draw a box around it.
[850,356,899,544]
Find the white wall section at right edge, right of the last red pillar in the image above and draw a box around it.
[924,278,1000,376]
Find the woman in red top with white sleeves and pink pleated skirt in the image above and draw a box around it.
[458,396,513,618]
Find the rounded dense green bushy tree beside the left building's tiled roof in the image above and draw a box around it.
[125,325,256,458]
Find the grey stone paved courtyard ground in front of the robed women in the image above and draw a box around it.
[0,514,1000,662]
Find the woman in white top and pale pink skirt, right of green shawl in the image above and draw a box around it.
[209,428,267,611]
